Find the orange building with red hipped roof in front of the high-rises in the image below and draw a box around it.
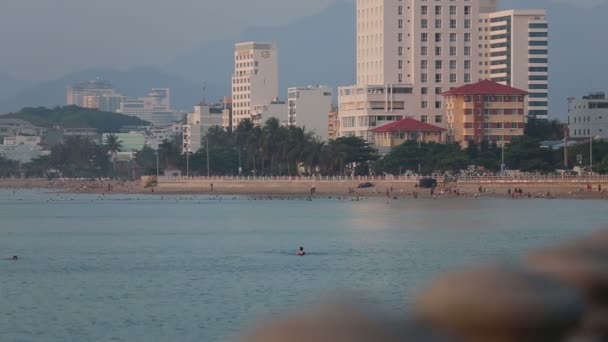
[442,80,528,147]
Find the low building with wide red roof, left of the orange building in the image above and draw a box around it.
[372,118,446,154]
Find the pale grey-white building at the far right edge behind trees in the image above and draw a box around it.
[568,93,608,139]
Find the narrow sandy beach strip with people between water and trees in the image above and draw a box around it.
[0,179,608,199]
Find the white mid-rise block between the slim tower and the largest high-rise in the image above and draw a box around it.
[287,86,332,140]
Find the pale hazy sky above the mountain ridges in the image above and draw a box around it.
[0,0,608,81]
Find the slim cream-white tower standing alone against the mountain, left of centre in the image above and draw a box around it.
[232,42,279,127]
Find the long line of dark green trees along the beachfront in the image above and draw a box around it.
[0,119,608,179]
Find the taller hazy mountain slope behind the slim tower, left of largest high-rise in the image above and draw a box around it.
[163,2,356,97]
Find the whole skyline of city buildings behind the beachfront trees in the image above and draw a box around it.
[0,0,608,174]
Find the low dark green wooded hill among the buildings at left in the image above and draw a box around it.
[1,106,150,133]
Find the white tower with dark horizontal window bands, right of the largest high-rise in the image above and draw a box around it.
[479,10,549,119]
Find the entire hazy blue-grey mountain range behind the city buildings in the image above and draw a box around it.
[0,0,608,119]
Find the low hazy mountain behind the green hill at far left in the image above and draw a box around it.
[0,67,214,113]
